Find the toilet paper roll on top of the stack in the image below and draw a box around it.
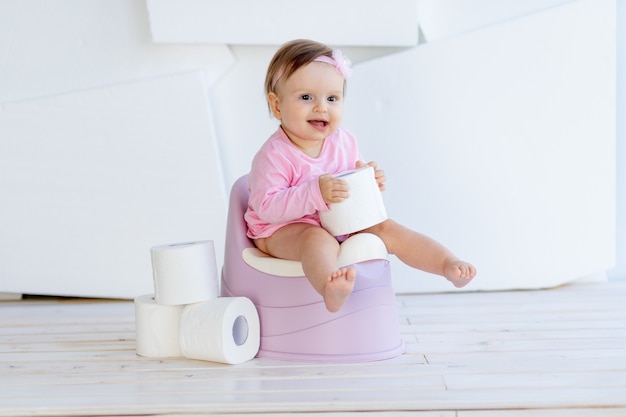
[150,240,219,305]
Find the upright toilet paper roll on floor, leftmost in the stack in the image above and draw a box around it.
[135,294,184,358]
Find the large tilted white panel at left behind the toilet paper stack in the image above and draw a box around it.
[0,72,226,297]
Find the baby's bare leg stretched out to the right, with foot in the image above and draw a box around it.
[366,220,476,288]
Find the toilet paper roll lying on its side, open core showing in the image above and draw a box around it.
[180,297,261,364]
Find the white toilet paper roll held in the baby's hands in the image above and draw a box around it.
[319,166,387,236]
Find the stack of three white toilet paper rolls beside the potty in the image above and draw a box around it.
[134,240,260,364]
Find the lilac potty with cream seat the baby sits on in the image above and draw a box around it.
[221,176,404,362]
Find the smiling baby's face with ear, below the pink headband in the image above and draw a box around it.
[268,62,344,147]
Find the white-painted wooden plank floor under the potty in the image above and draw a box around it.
[0,281,626,417]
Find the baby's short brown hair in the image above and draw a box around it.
[265,39,333,96]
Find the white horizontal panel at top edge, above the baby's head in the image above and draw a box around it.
[147,0,418,47]
